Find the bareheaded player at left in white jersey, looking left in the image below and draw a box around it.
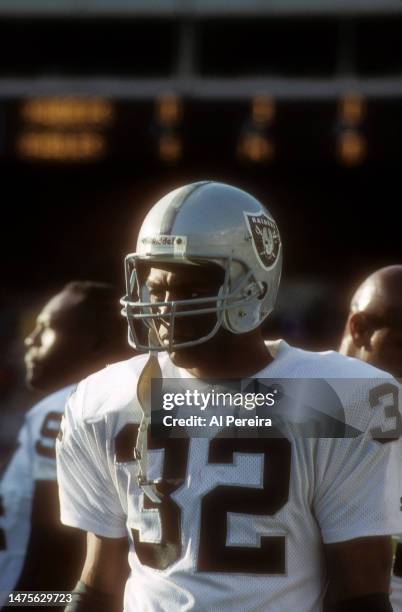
[0,282,127,606]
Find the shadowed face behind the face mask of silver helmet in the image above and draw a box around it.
[143,264,223,354]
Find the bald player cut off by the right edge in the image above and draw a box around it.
[340,265,402,612]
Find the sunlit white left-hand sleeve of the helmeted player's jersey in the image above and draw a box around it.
[56,383,126,538]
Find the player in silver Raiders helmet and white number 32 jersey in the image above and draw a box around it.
[57,181,402,612]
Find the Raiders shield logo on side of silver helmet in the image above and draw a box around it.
[244,212,281,270]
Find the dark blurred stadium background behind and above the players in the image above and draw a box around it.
[0,0,402,448]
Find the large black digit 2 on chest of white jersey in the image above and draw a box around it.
[198,438,291,574]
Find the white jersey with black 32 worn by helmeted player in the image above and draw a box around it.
[57,341,402,612]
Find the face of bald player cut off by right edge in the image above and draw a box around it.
[367,326,402,378]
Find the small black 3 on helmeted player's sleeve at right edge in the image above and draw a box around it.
[369,383,402,444]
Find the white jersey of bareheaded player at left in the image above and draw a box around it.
[0,385,74,608]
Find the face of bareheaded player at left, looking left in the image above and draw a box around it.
[25,292,92,391]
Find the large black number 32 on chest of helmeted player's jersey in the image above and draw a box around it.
[115,424,291,575]
